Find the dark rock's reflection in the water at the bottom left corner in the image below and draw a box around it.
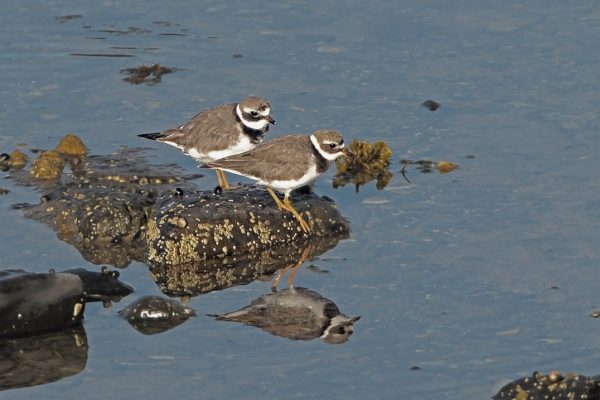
[0,325,88,390]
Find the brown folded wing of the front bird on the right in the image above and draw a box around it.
[207,135,314,180]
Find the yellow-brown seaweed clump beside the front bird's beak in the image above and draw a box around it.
[333,140,393,192]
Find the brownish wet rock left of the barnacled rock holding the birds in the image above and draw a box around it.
[19,149,201,267]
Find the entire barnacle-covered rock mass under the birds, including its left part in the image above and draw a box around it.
[11,139,349,274]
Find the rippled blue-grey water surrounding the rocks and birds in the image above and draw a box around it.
[0,0,600,399]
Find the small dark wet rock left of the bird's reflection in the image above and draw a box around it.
[119,296,196,335]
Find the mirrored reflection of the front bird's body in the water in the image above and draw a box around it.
[214,287,360,344]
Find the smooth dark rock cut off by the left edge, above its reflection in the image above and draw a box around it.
[0,270,85,337]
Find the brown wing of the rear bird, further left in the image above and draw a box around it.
[161,104,244,153]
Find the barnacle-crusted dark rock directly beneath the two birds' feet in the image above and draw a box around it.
[146,186,349,266]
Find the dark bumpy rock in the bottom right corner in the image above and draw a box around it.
[493,371,600,400]
